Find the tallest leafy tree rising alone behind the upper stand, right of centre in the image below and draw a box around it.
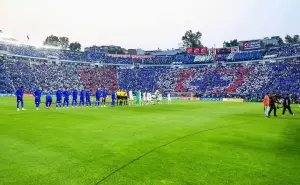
[181,30,202,48]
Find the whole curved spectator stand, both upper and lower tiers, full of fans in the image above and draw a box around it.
[0,41,300,97]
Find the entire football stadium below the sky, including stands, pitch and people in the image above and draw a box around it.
[0,0,300,185]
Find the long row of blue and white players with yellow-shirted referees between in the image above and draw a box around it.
[15,86,171,111]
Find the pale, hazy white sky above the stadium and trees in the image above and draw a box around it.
[0,0,300,49]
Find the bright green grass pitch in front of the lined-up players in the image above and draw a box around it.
[0,97,300,185]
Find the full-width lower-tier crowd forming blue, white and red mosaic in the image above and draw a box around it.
[0,59,300,97]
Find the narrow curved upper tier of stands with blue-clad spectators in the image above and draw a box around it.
[0,43,300,65]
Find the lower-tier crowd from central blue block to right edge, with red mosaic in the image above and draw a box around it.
[118,60,300,98]
